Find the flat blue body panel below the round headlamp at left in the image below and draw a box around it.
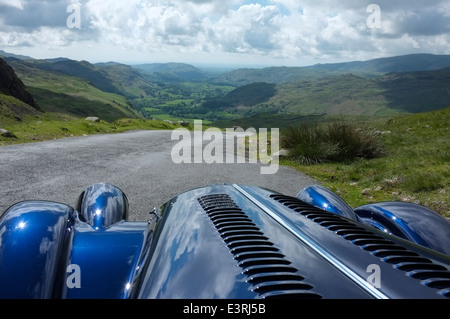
[61,222,151,299]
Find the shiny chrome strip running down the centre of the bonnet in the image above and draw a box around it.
[233,184,389,299]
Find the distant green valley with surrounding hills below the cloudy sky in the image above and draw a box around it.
[0,51,450,123]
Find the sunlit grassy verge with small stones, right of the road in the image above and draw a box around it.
[282,108,450,217]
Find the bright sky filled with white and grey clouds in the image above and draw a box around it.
[0,0,450,66]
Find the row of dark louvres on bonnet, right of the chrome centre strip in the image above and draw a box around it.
[270,194,450,298]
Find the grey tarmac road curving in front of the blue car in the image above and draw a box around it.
[0,131,317,221]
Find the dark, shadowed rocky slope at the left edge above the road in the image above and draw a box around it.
[0,58,40,111]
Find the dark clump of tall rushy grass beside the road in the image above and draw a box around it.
[281,122,385,165]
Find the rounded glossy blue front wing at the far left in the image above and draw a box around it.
[0,201,74,299]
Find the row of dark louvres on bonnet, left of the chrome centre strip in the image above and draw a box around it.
[198,194,322,299]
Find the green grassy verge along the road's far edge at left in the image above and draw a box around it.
[0,113,186,146]
